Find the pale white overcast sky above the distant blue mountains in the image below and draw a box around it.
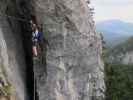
[90,0,133,23]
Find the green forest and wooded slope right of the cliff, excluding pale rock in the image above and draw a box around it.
[102,33,133,100]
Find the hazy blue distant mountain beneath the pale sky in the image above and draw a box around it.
[96,20,133,46]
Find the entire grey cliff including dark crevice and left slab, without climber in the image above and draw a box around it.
[0,0,105,100]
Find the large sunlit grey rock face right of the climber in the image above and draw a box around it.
[33,0,105,100]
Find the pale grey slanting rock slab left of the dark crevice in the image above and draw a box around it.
[0,8,26,100]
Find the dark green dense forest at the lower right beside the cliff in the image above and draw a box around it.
[105,64,133,100]
